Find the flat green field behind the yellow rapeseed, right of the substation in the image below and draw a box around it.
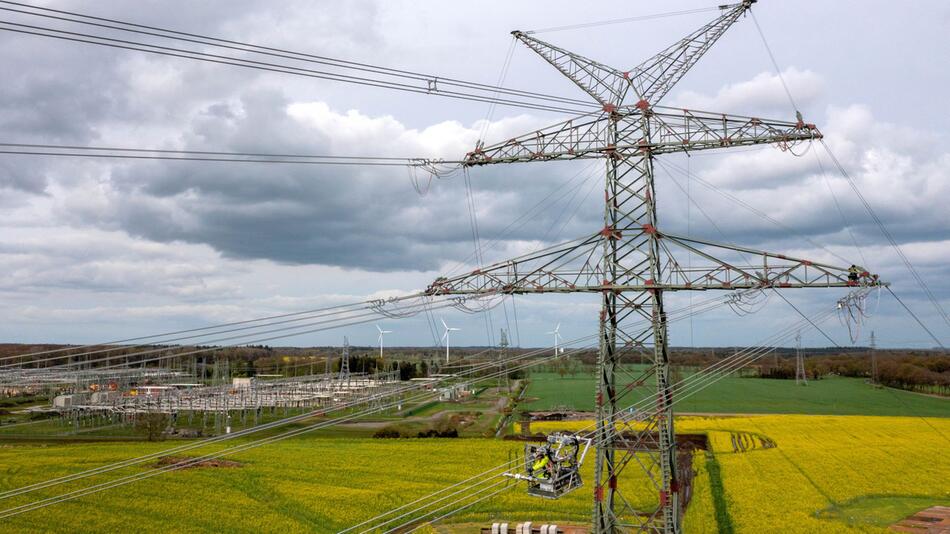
[519,373,950,417]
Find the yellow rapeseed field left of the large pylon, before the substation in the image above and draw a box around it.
[0,438,656,533]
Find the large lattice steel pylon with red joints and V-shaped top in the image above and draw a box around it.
[427,0,879,533]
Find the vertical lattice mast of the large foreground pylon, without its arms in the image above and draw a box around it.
[593,119,680,534]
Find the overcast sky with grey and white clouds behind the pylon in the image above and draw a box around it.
[0,0,950,347]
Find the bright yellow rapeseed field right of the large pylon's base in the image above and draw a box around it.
[531,415,950,533]
